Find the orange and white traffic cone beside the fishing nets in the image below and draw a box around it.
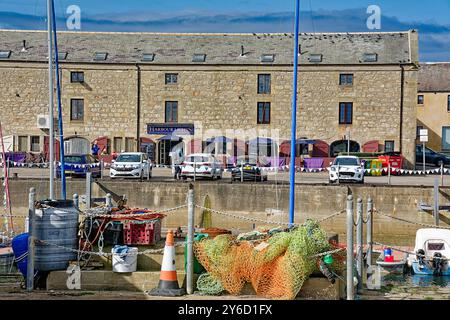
[148,230,186,297]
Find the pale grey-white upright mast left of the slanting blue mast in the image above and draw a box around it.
[47,0,55,200]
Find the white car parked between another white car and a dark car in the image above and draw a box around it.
[181,153,223,180]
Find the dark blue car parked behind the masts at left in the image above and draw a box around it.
[56,154,101,178]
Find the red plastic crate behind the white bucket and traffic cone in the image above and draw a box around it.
[123,220,161,245]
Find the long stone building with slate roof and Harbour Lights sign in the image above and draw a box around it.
[0,30,418,165]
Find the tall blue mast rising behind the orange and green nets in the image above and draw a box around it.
[289,0,300,226]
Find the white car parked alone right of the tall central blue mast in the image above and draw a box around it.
[330,156,364,183]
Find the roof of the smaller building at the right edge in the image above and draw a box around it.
[418,62,450,92]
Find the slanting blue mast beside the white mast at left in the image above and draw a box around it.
[51,0,67,200]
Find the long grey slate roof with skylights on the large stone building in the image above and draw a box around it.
[0,30,418,65]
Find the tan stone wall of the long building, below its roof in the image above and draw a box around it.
[0,63,417,163]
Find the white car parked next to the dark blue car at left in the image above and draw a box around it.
[110,152,152,180]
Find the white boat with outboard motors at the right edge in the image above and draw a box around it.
[408,228,450,276]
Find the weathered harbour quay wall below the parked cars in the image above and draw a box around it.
[10,179,450,245]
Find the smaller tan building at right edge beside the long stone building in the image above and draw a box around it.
[417,63,450,152]
